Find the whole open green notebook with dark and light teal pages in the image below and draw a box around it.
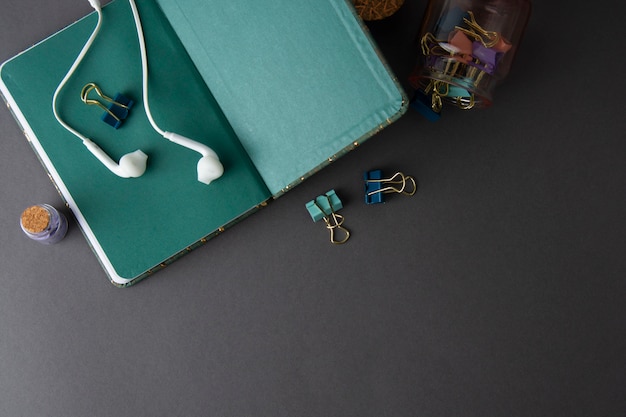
[0,0,407,286]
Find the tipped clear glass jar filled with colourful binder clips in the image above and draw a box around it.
[409,0,531,113]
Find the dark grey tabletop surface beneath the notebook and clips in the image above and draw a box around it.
[0,0,626,417]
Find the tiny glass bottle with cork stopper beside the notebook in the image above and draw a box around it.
[20,204,67,245]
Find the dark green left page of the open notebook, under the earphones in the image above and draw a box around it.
[1,1,271,285]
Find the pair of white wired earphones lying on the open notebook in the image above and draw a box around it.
[52,0,224,184]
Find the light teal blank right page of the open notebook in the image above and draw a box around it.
[157,0,407,195]
